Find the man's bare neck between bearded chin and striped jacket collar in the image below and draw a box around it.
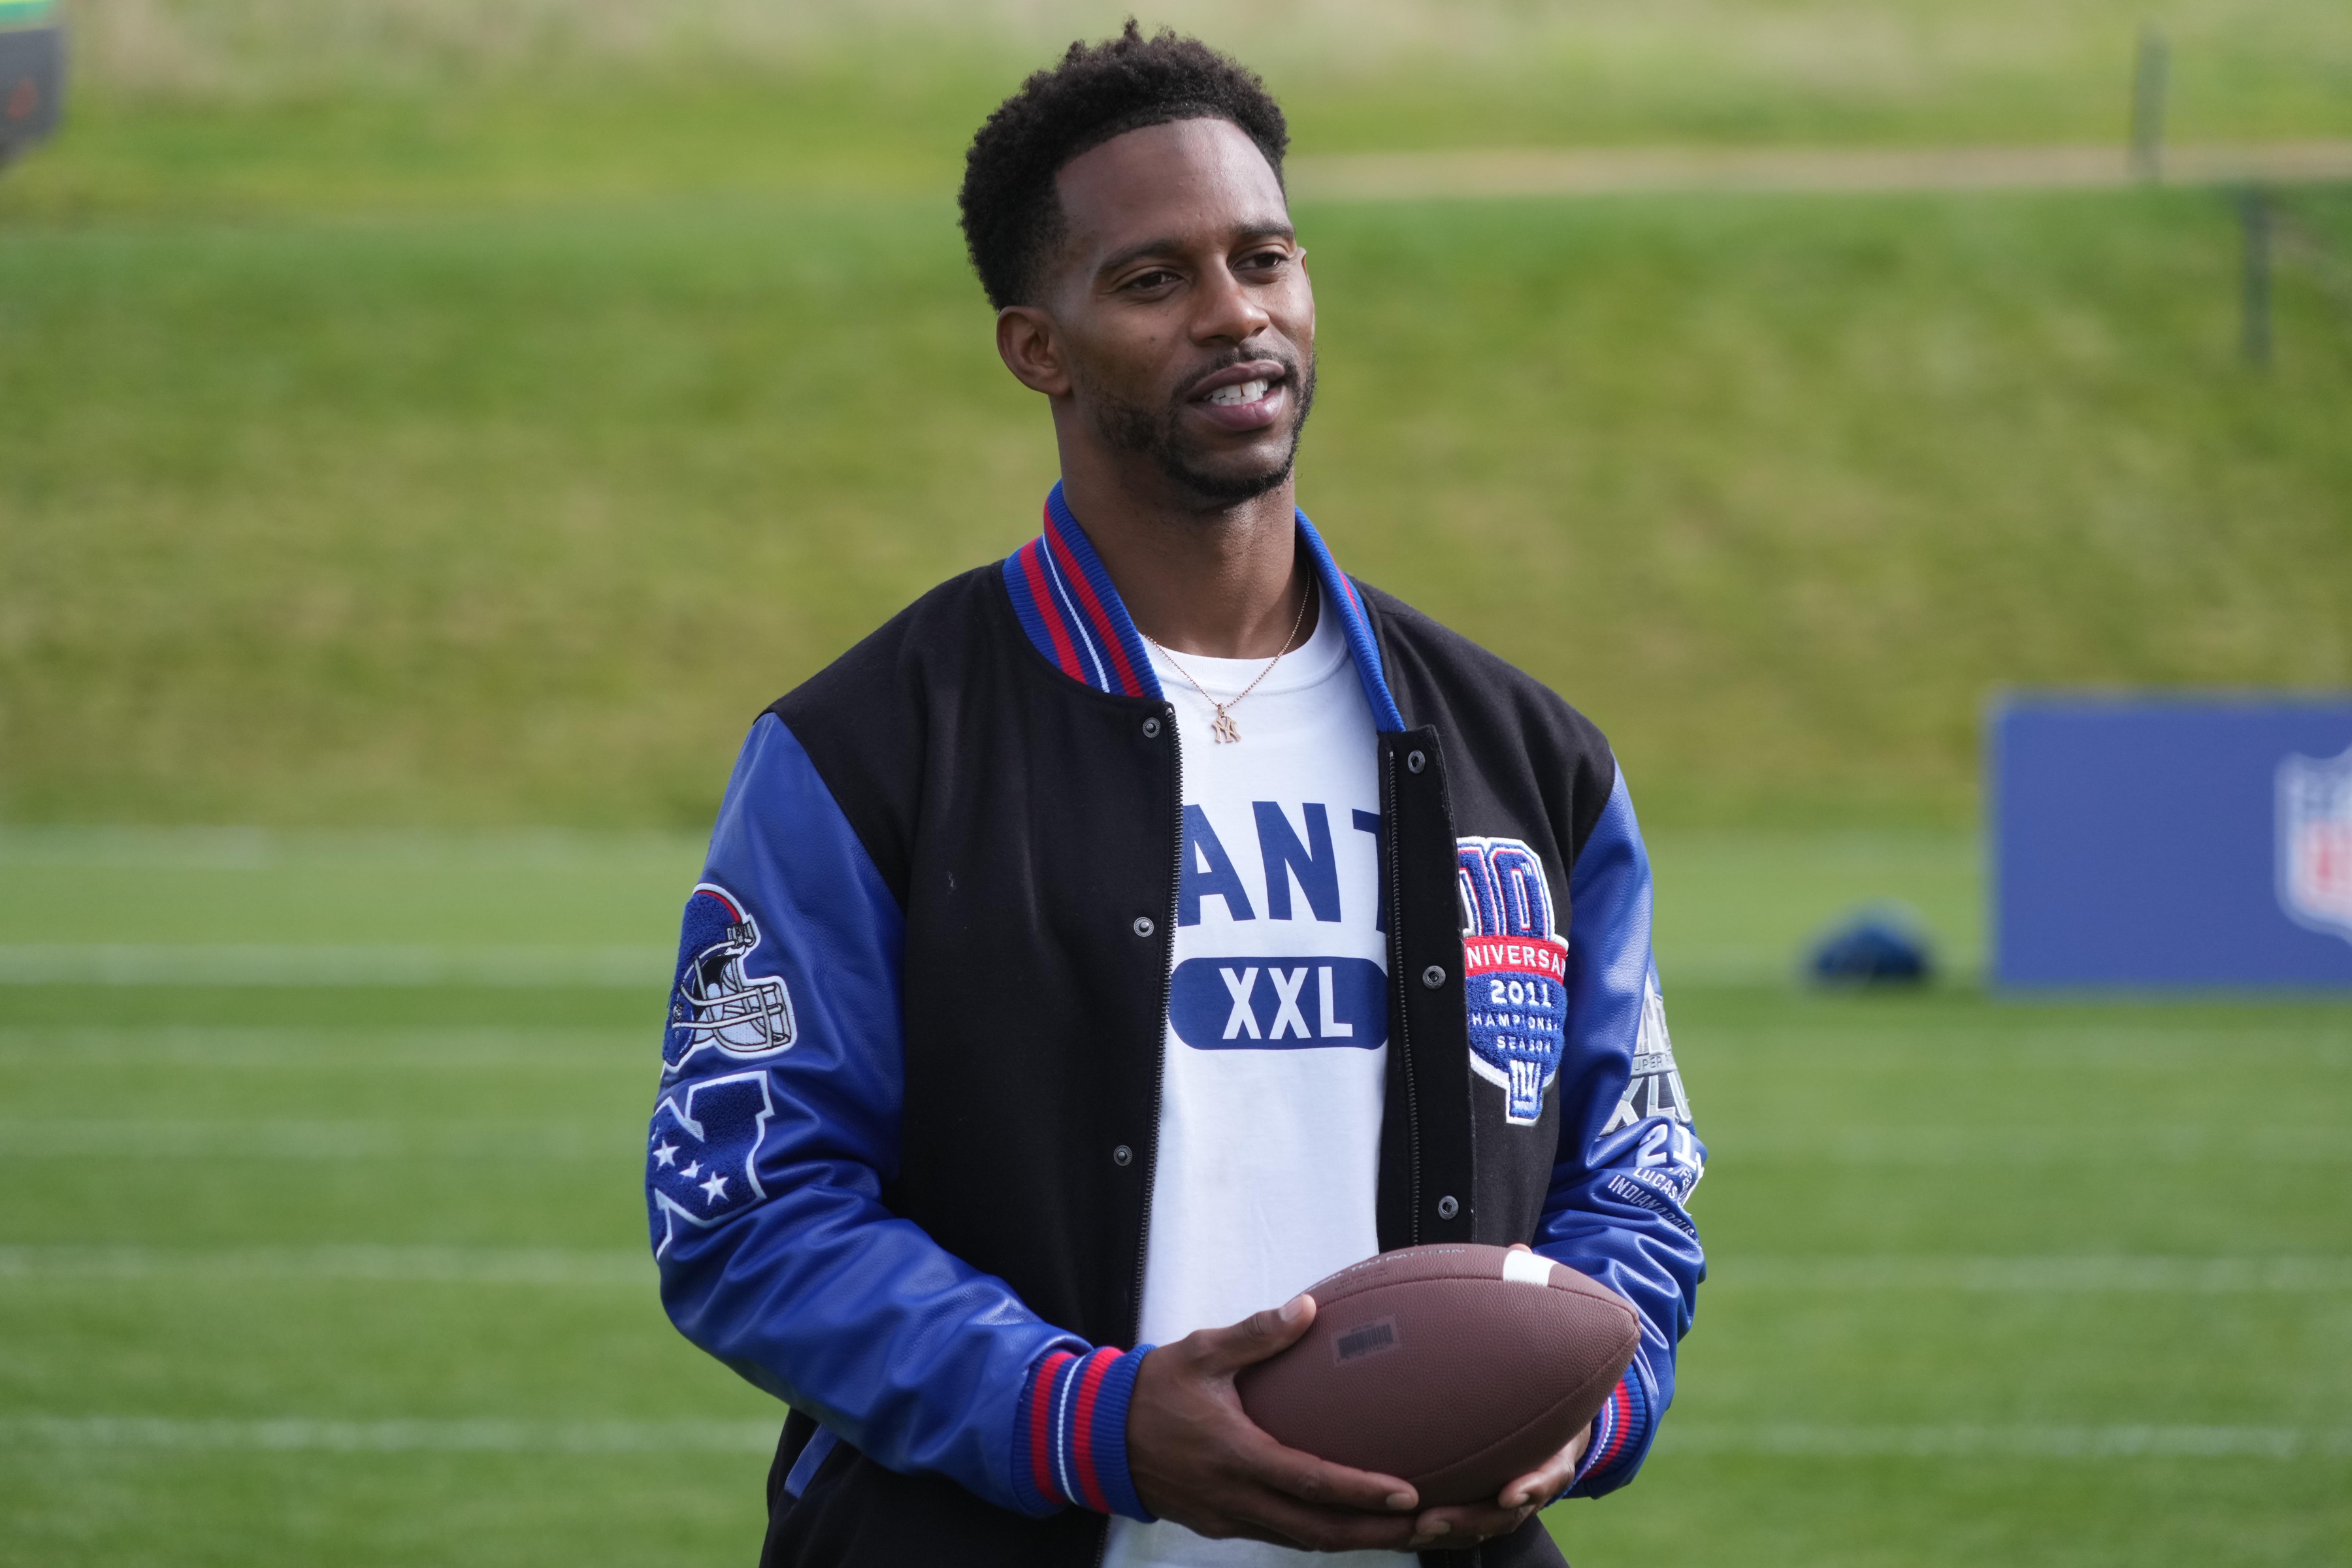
[1061,449,1317,658]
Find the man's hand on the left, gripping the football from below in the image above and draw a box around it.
[1126,1296,1420,1552]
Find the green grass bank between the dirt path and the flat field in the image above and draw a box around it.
[0,193,2352,830]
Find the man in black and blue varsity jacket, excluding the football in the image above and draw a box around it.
[647,24,1705,1568]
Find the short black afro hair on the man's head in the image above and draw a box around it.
[957,16,1291,310]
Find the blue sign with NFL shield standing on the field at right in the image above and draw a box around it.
[1987,696,2352,987]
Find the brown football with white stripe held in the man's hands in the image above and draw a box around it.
[1235,1246,1642,1507]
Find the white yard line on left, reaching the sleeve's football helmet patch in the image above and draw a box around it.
[0,943,678,990]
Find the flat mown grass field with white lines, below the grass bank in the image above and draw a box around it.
[0,832,2352,1568]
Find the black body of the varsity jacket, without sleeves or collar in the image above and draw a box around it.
[762,566,1616,1568]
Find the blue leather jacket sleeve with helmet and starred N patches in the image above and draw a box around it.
[647,715,1089,1512]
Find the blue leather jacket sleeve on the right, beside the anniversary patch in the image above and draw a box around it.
[1536,774,1708,1495]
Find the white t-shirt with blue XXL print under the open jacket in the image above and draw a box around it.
[1103,604,1414,1568]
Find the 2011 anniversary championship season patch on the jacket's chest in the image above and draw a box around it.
[1456,840,1569,1126]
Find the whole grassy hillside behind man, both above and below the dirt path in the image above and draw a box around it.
[0,0,2352,830]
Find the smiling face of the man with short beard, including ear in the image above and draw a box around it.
[1000,120,1315,506]
